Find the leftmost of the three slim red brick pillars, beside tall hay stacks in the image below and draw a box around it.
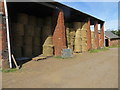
[87,18,92,50]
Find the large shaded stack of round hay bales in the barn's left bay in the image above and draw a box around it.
[11,13,43,58]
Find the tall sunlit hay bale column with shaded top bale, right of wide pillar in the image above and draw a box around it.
[74,22,82,53]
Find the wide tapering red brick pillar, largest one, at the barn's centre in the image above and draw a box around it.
[53,11,66,56]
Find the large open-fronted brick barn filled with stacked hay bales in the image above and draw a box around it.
[0,2,104,68]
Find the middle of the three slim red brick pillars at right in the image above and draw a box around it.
[94,20,99,49]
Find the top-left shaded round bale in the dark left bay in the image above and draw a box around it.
[17,13,28,24]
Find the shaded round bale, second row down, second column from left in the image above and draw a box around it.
[24,25,35,36]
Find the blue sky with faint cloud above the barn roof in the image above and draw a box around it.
[55,2,118,30]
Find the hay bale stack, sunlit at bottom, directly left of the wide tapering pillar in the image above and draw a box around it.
[42,17,53,56]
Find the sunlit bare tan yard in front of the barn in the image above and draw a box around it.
[2,48,118,88]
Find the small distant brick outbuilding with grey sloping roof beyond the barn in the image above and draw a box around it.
[105,31,120,47]
